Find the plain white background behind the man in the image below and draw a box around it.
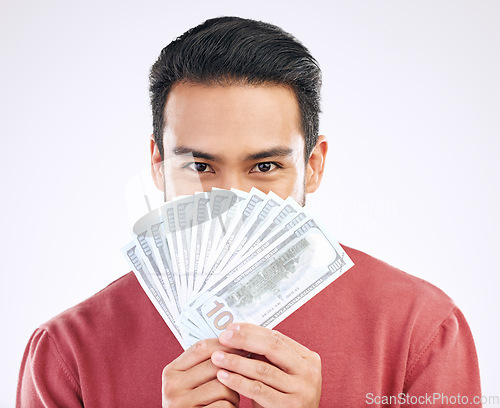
[0,0,500,407]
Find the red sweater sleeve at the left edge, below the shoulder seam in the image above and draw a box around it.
[16,329,83,408]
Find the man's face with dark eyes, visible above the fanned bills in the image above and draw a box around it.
[151,83,326,203]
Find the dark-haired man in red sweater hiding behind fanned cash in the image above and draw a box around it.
[17,17,480,407]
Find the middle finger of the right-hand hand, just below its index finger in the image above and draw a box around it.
[212,351,297,392]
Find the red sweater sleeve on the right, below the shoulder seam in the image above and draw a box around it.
[402,307,481,407]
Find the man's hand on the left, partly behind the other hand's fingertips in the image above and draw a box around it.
[162,339,243,408]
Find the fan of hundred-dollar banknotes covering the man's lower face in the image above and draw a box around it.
[122,189,353,349]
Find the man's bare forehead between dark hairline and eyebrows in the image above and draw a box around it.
[164,83,304,150]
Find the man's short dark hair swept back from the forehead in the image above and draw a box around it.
[149,17,321,161]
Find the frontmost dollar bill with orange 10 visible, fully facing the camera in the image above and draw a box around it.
[183,219,353,335]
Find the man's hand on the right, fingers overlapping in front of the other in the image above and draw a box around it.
[212,323,321,408]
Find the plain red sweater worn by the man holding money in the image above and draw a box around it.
[17,248,480,408]
